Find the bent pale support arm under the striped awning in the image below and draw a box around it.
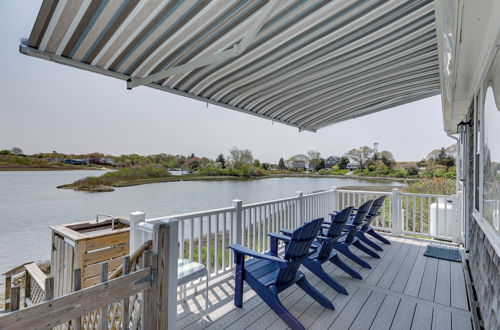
[127,0,278,89]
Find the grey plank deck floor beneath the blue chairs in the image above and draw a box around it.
[178,237,472,330]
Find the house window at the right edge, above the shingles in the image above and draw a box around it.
[482,88,500,231]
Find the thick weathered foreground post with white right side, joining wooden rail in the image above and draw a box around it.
[152,219,179,330]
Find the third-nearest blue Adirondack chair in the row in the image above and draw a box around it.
[334,200,380,268]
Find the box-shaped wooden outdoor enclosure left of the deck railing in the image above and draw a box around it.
[51,218,130,297]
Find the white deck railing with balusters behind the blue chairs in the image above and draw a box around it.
[130,187,461,288]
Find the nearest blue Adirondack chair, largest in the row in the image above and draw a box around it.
[230,218,334,330]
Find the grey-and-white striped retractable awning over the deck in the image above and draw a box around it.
[21,0,440,131]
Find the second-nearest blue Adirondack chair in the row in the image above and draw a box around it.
[280,206,362,295]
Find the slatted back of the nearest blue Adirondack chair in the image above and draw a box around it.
[276,218,323,285]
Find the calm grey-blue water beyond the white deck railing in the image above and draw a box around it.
[0,171,401,274]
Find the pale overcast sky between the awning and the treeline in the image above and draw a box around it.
[0,0,454,162]
